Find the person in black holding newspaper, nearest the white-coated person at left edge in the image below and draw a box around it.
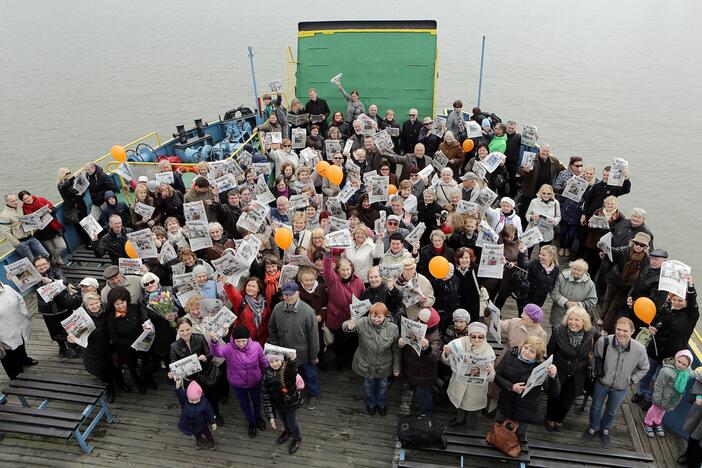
[34,257,82,358]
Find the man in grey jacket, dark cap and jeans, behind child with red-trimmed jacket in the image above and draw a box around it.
[268,281,324,410]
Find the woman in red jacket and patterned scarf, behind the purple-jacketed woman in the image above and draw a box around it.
[224,276,271,346]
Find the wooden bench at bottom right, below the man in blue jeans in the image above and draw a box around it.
[529,441,656,468]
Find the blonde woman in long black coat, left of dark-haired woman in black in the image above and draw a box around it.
[68,292,115,403]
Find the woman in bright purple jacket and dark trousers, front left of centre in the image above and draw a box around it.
[210,325,268,438]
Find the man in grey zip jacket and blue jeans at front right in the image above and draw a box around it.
[582,317,649,448]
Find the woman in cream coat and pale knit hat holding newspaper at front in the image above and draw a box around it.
[441,322,495,429]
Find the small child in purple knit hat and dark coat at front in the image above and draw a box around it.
[176,380,217,451]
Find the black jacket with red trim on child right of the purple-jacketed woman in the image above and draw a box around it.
[261,359,304,419]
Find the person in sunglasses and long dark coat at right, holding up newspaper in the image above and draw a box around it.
[597,232,651,333]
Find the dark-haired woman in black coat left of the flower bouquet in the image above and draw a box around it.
[107,286,158,394]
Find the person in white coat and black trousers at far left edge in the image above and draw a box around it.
[0,283,38,380]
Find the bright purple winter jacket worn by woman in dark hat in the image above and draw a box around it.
[210,338,268,388]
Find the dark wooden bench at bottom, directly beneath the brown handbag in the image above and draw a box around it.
[398,431,530,468]
